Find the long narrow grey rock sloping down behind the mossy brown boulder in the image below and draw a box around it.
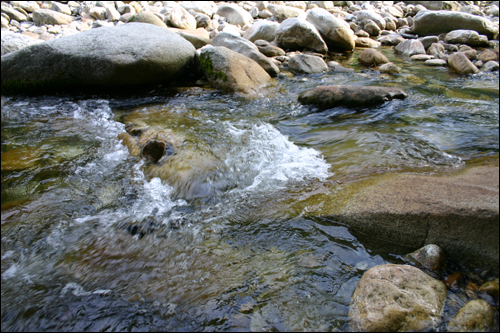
[212,32,280,77]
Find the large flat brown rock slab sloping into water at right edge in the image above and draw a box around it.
[309,166,499,270]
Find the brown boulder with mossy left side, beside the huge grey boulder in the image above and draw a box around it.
[200,45,271,93]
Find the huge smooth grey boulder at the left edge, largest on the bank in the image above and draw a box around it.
[2,23,196,91]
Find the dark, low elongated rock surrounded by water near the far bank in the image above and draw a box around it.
[298,85,407,109]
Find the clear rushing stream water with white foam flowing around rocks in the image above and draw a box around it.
[1,48,499,331]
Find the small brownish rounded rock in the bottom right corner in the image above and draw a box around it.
[448,299,495,332]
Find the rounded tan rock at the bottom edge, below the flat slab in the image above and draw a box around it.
[349,264,447,332]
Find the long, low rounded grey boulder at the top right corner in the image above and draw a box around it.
[412,10,498,39]
